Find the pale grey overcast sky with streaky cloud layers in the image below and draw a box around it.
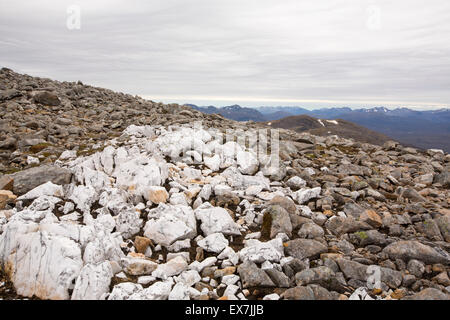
[0,0,450,109]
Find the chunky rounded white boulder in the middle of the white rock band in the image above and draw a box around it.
[144,203,197,246]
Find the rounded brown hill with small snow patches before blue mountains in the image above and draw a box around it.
[266,115,392,145]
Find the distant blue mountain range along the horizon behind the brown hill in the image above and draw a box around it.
[188,105,450,152]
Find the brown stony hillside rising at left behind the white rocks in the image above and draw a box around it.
[0,68,266,174]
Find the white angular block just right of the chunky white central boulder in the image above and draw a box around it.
[194,202,241,236]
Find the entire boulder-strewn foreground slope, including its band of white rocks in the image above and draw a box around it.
[0,69,450,300]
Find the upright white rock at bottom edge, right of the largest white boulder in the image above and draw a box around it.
[72,261,113,300]
